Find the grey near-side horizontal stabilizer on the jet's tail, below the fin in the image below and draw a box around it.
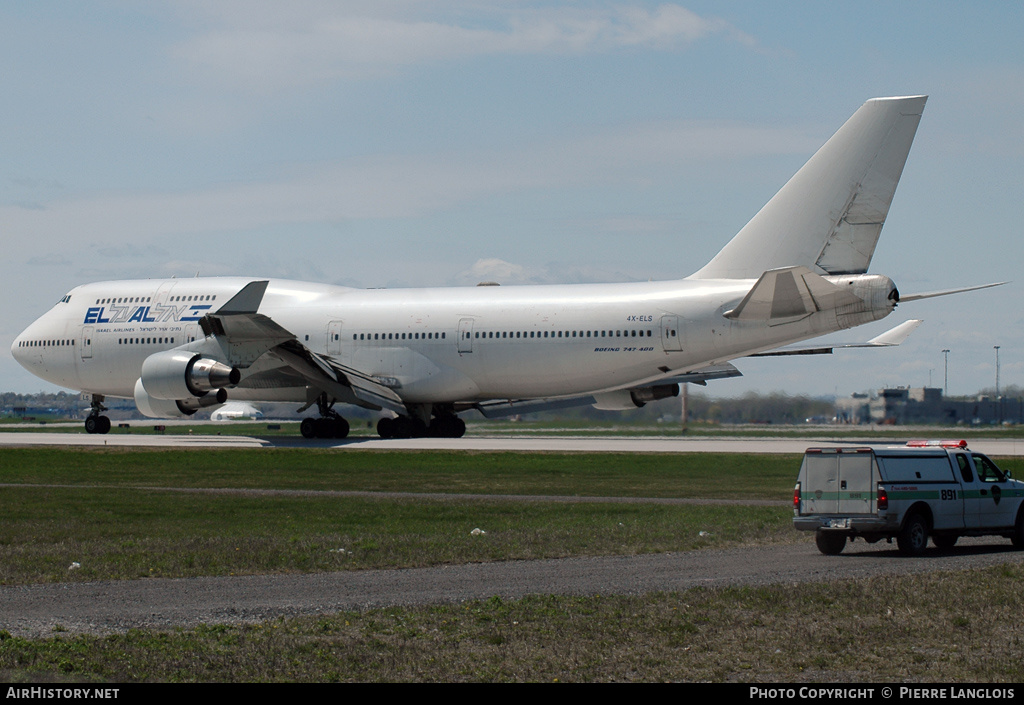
[725,266,863,323]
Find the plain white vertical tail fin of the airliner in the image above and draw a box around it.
[692,95,928,279]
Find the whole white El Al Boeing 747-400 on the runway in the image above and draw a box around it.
[11,95,994,438]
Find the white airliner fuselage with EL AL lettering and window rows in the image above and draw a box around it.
[12,275,893,404]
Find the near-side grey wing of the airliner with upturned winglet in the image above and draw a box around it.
[200,281,407,414]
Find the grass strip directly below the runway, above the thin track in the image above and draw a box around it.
[0,448,800,500]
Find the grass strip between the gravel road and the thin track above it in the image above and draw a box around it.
[0,488,797,585]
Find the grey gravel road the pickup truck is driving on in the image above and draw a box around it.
[0,538,1024,636]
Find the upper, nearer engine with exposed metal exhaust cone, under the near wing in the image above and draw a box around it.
[140,350,242,400]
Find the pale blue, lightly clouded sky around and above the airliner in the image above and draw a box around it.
[0,0,1024,397]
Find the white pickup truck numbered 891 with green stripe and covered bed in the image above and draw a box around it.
[793,441,1024,555]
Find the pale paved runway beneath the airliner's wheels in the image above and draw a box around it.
[0,431,1024,457]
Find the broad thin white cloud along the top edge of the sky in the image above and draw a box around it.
[174,1,756,92]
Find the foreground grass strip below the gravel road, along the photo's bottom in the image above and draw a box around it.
[0,566,1024,688]
